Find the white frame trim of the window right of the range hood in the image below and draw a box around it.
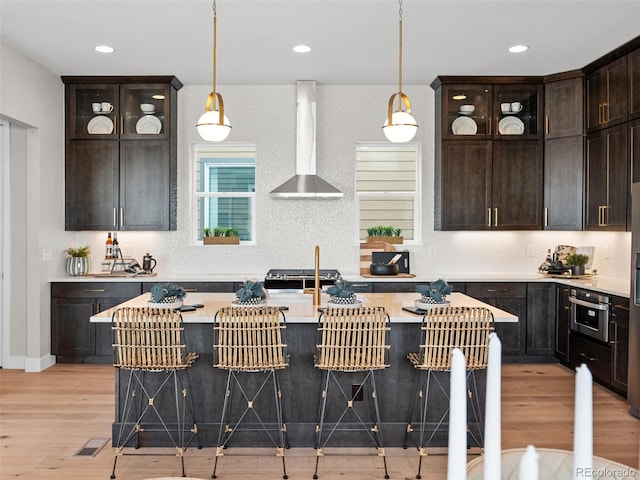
[353,142,423,246]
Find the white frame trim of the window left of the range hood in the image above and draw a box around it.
[189,142,258,247]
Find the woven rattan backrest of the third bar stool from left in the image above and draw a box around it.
[315,307,391,371]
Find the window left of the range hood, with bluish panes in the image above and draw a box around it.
[194,144,256,242]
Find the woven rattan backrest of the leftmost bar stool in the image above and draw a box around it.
[111,307,197,371]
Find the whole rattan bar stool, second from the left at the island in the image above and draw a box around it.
[212,306,289,479]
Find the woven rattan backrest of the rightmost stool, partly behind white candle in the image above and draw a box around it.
[414,307,493,370]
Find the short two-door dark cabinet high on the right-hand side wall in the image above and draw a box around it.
[585,56,628,132]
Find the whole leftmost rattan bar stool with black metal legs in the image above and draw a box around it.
[111,308,200,478]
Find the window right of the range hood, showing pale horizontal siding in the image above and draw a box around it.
[356,143,421,243]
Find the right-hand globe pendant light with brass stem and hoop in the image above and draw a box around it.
[382,0,418,143]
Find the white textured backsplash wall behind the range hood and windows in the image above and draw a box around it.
[78,82,630,278]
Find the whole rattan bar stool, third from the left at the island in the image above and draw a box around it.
[313,307,391,478]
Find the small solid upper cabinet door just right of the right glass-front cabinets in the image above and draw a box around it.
[544,72,584,139]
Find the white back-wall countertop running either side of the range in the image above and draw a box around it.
[50,272,631,298]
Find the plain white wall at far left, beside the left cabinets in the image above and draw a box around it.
[0,42,67,371]
